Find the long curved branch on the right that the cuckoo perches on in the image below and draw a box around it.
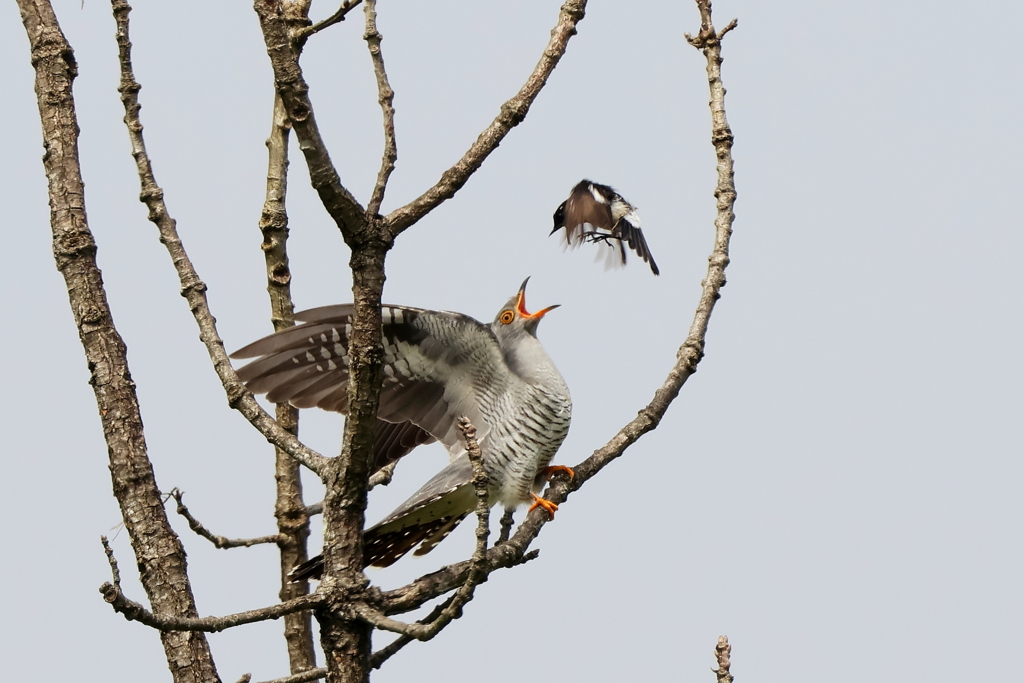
[382,0,736,614]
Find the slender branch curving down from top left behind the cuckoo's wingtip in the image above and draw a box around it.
[112,0,327,473]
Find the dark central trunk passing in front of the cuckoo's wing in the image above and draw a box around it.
[254,22,393,667]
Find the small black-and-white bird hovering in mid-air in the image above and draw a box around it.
[551,180,660,275]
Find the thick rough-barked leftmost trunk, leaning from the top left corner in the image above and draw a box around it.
[17,0,219,683]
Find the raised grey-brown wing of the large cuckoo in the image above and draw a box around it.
[231,304,516,467]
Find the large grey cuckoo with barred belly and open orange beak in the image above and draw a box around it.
[231,278,572,581]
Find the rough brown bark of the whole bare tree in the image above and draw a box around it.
[18,0,736,683]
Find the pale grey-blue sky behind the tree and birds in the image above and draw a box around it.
[0,0,1024,683]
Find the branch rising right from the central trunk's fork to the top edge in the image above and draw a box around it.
[385,0,587,237]
